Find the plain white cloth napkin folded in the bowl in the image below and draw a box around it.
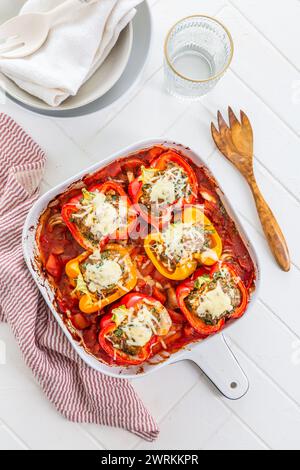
[0,0,143,107]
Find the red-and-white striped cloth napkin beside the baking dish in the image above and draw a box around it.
[0,114,158,441]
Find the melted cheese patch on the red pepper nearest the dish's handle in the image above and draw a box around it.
[197,282,233,320]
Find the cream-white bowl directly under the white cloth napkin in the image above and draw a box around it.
[0,0,133,113]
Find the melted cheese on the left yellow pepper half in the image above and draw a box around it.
[84,260,122,293]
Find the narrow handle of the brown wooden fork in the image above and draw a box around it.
[249,178,291,272]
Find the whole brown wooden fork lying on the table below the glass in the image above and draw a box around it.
[211,107,291,272]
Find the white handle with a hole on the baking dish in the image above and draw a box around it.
[187,334,249,400]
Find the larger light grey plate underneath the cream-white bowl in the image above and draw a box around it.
[0,0,153,118]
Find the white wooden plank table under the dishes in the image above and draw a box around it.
[0,0,300,449]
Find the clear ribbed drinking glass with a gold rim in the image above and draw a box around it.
[164,15,234,100]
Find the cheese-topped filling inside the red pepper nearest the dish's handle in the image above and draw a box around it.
[185,269,242,326]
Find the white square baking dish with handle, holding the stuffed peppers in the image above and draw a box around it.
[23,139,260,399]
